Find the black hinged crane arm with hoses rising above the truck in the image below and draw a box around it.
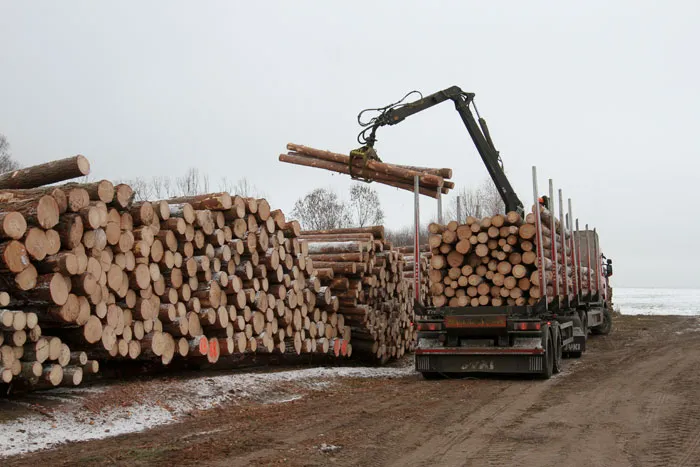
[358,86,524,214]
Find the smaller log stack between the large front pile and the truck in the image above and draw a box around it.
[301,226,415,362]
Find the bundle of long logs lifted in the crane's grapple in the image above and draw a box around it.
[279,143,454,198]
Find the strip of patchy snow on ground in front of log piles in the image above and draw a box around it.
[0,359,414,458]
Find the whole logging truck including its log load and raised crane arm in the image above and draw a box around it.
[353,86,612,378]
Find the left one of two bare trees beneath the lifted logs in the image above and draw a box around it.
[292,188,351,230]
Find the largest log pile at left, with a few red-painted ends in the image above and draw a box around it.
[0,156,370,394]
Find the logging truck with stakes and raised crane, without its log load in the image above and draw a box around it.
[351,86,612,379]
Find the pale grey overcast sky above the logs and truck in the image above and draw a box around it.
[0,0,700,287]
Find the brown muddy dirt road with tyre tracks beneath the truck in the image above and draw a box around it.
[2,317,700,466]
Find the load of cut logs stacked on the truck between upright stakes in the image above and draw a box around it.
[428,206,587,307]
